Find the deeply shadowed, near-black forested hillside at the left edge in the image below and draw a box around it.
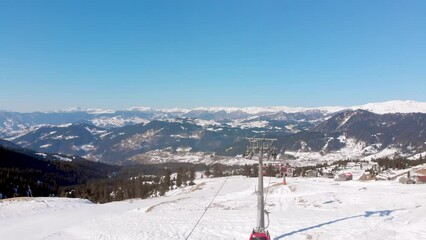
[0,146,119,198]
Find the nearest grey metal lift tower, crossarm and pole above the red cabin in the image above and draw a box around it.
[248,138,277,236]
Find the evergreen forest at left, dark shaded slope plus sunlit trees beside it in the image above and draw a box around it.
[0,146,206,203]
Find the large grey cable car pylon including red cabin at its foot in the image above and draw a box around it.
[247,138,277,240]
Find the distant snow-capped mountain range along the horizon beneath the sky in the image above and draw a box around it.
[0,101,426,134]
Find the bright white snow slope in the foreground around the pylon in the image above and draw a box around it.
[0,176,426,240]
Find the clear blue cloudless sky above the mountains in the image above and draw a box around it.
[0,0,426,111]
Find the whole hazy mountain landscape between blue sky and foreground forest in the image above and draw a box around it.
[0,101,426,163]
